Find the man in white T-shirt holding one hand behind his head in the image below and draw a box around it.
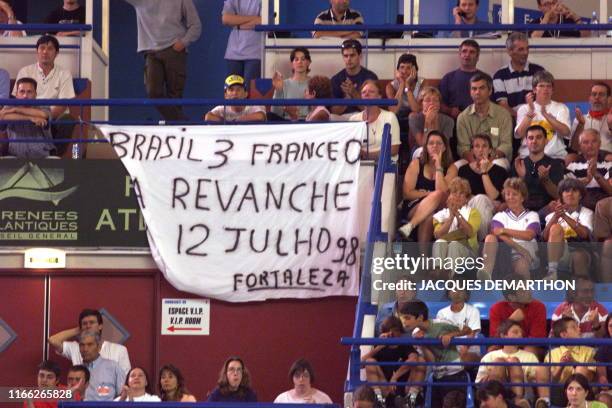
[49,309,131,374]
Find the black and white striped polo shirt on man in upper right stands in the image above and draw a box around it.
[493,62,544,110]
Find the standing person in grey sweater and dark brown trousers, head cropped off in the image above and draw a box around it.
[125,0,202,120]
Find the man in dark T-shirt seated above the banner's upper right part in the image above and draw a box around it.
[331,40,378,115]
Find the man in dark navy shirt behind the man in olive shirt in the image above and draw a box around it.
[440,39,483,119]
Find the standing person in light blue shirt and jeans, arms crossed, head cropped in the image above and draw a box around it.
[221,0,264,89]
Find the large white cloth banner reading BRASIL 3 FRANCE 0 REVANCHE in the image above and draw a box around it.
[101,122,366,302]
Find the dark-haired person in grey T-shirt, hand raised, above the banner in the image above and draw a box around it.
[270,47,312,120]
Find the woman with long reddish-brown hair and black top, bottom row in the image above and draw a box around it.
[207,357,257,402]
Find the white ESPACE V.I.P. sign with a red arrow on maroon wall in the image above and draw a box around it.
[162,299,210,336]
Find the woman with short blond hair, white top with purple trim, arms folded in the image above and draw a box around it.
[478,177,540,280]
